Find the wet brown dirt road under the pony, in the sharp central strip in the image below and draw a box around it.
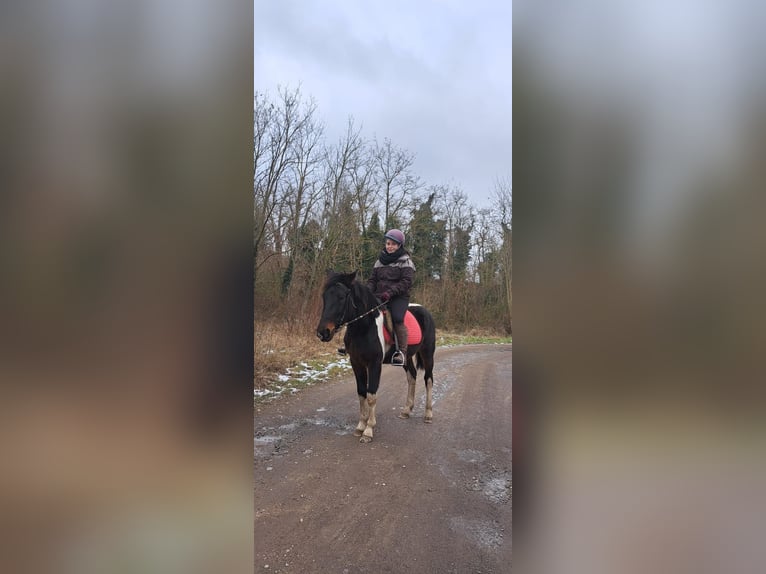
[255,345,512,574]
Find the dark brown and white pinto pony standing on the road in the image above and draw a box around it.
[316,270,436,443]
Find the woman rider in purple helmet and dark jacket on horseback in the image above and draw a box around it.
[367,229,415,366]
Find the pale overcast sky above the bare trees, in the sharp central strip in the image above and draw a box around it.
[254,0,512,207]
